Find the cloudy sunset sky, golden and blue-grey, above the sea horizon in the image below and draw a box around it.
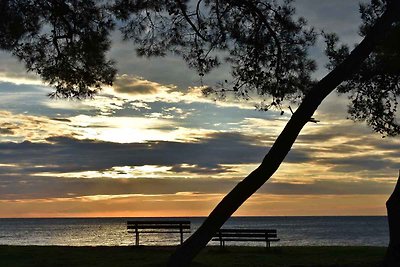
[0,0,400,217]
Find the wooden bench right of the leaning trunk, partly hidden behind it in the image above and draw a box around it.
[211,229,280,248]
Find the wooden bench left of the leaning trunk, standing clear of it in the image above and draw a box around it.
[127,220,190,246]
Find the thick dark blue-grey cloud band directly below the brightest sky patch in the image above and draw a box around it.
[0,132,318,178]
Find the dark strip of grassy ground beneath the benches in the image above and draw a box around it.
[0,246,385,267]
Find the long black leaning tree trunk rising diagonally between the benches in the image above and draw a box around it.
[168,0,400,267]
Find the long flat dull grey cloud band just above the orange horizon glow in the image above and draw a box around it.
[0,176,395,200]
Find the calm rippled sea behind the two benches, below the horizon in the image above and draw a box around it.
[0,216,389,246]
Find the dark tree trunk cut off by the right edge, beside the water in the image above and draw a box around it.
[385,171,400,267]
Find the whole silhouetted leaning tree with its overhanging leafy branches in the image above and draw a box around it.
[0,0,400,266]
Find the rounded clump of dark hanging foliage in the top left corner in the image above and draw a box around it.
[0,0,116,98]
